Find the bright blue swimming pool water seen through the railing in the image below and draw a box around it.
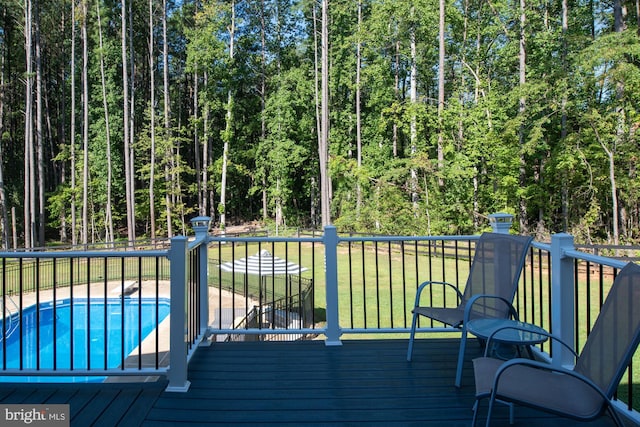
[0,298,170,382]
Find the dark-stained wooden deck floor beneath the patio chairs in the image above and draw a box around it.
[0,339,632,427]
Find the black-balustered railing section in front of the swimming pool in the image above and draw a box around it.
[0,252,170,376]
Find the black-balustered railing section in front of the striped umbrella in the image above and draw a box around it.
[209,236,324,339]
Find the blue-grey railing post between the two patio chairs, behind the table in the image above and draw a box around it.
[551,233,576,366]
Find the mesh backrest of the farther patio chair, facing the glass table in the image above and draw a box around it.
[460,233,533,318]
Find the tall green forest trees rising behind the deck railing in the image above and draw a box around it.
[0,0,640,249]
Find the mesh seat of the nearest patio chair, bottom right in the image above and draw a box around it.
[473,357,605,419]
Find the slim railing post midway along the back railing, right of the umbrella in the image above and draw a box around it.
[324,225,342,345]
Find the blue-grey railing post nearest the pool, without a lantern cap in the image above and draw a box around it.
[166,236,191,392]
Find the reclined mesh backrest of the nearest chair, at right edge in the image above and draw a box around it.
[574,262,640,398]
